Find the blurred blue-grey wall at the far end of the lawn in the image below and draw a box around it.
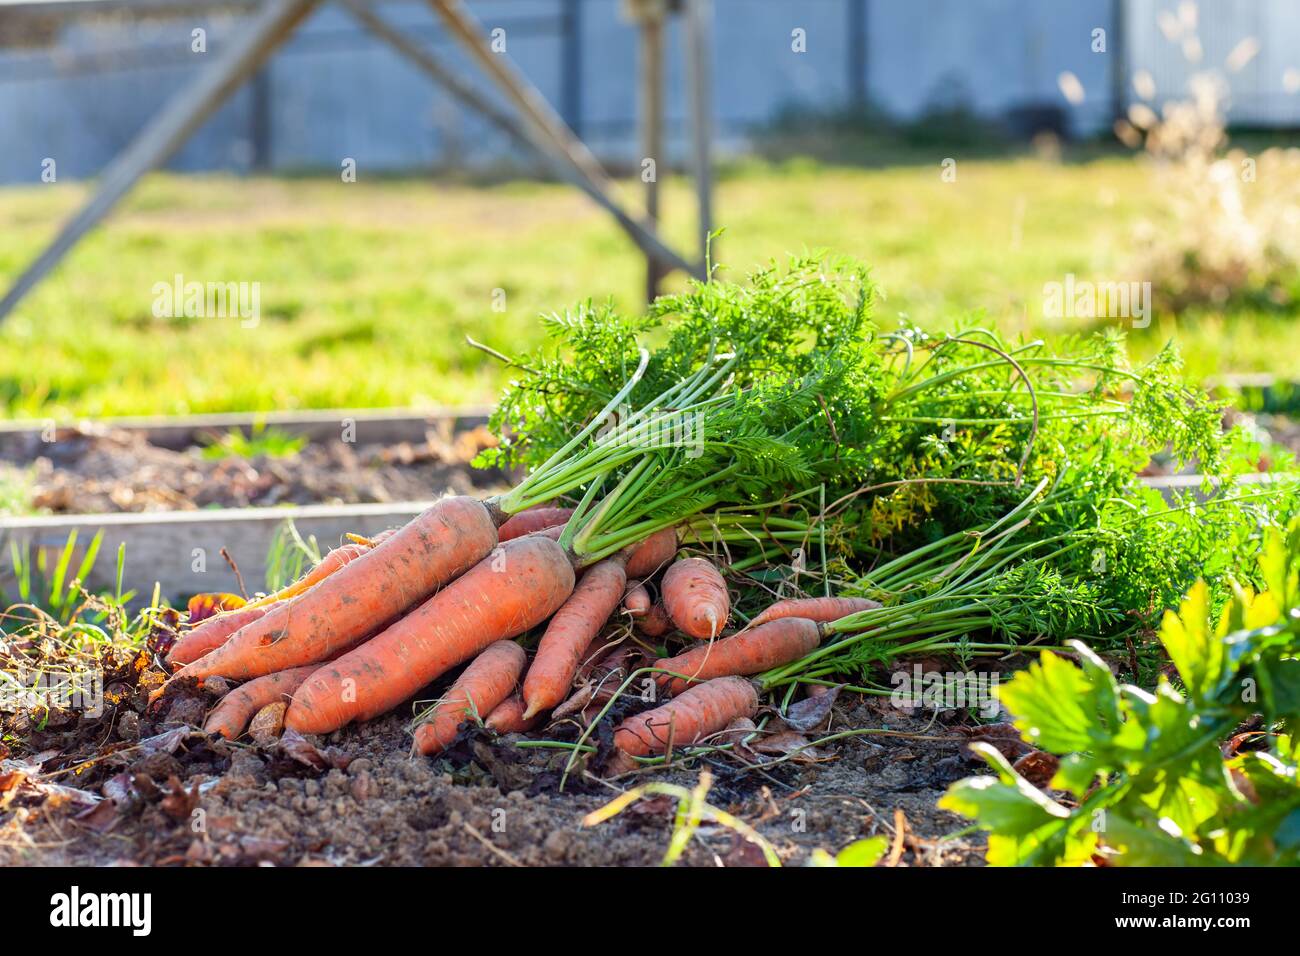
[0,0,1300,182]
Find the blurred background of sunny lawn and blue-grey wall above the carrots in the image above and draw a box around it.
[0,0,1300,420]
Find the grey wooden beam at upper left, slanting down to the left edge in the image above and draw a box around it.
[0,0,317,321]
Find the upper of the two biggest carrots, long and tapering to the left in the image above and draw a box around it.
[173,497,497,679]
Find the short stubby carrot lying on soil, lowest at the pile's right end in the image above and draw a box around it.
[614,678,758,757]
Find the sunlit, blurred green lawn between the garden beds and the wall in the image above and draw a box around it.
[0,156,1300,418]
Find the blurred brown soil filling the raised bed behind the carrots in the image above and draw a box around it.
[0,428,504,514]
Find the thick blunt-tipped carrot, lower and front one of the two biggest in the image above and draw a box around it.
[285,535,573,734]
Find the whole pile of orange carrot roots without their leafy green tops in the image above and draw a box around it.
[168,497,875,771]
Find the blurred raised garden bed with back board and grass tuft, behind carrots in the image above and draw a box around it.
[0,410,501,514]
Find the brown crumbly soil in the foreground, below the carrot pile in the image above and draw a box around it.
[0,665,982,866]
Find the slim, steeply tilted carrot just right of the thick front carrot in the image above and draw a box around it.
[524,553,628,718]
